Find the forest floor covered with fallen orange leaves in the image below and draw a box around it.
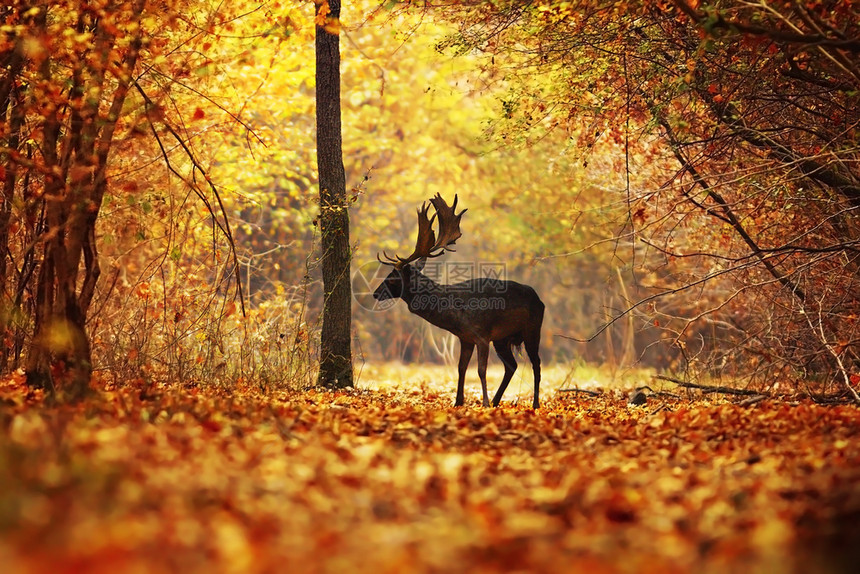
[0,366,860,574]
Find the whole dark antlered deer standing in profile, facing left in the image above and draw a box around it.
[373,193,544,409]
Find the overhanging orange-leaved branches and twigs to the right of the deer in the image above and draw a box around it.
[414,1,860,394]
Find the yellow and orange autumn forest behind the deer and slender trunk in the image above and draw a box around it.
[0,0,860,396]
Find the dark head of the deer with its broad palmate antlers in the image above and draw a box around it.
[373,193,466,301]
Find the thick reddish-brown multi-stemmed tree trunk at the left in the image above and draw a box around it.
[26,0,146,400]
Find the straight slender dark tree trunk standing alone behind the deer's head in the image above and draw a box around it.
[316,0,353,388]
